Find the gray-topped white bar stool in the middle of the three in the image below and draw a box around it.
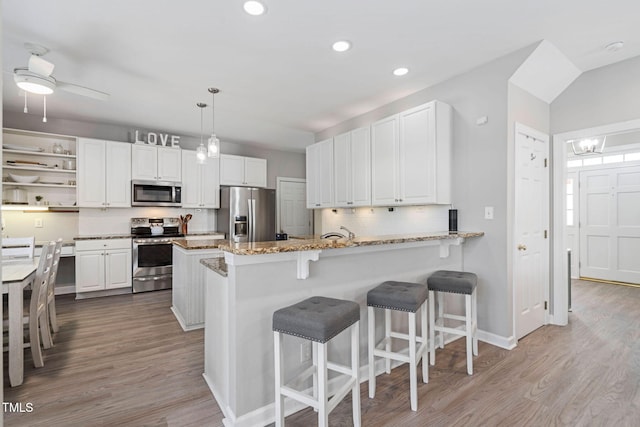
[367,281,429,411]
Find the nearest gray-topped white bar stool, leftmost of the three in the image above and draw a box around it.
[273,297,360,426]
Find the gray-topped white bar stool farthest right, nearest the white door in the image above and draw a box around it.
[427,270,478,375]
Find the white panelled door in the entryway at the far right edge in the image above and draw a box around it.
[580,166,640,284]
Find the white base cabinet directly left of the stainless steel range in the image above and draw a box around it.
[76,239,131,293]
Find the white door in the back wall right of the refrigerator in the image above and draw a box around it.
[278,178,312,236]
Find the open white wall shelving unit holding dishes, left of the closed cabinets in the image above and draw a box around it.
[2,129,76,208]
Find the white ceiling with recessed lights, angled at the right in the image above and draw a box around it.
[2,0,640,151]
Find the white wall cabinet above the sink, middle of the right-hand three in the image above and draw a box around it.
[333,126,371,207]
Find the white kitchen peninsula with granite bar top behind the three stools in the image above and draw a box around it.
[201,232,484,426]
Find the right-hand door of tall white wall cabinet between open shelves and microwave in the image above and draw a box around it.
[105,141,131,208]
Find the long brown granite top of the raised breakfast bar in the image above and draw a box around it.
[219,231,484,255]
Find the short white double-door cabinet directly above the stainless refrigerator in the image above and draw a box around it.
[220,154,267,187]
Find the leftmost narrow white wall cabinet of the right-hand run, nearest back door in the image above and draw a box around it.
[306,138,334,209]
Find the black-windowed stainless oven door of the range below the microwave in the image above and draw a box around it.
[133,238,173,279]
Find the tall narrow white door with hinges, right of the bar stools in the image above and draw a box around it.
[513,125,549,339]
